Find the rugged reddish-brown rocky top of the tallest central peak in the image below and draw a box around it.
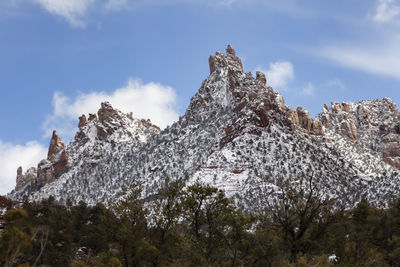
[185,45,324,140]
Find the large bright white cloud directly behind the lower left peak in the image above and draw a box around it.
[43,79,178,140]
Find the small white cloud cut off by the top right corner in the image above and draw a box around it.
[370,0,400,23]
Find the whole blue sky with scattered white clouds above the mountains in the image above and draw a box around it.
[0,0,400,194]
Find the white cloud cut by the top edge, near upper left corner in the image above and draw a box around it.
[33,0,95,28]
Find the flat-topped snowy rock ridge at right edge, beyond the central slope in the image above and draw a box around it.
[318,98,400,172]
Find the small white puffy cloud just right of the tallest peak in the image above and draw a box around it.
[256,61,294,90]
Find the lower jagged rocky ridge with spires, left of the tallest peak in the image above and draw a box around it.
[15,102,160,194]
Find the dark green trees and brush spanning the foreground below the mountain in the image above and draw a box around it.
[0,180,400,267]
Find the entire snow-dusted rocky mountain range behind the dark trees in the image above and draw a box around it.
[9,46,400,210]
